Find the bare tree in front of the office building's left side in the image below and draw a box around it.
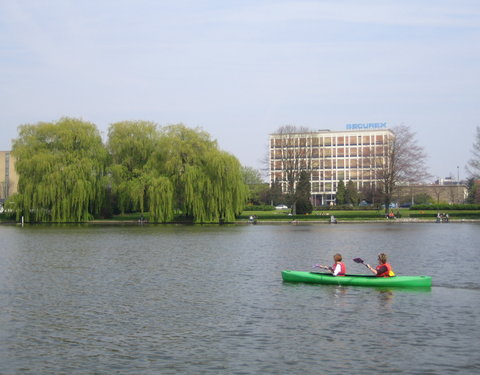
[270,125,311,214]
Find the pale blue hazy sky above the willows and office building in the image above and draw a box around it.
[0,0,480,179]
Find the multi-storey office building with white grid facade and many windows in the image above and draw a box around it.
[269,129,394,205]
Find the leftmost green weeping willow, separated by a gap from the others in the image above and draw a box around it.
[12,118,107,222]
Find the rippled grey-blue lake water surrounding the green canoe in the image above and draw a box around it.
[0,223,480,375]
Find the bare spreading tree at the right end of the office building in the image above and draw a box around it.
[377,125,430,212]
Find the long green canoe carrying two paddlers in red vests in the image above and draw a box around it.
[282,270,432,288]
